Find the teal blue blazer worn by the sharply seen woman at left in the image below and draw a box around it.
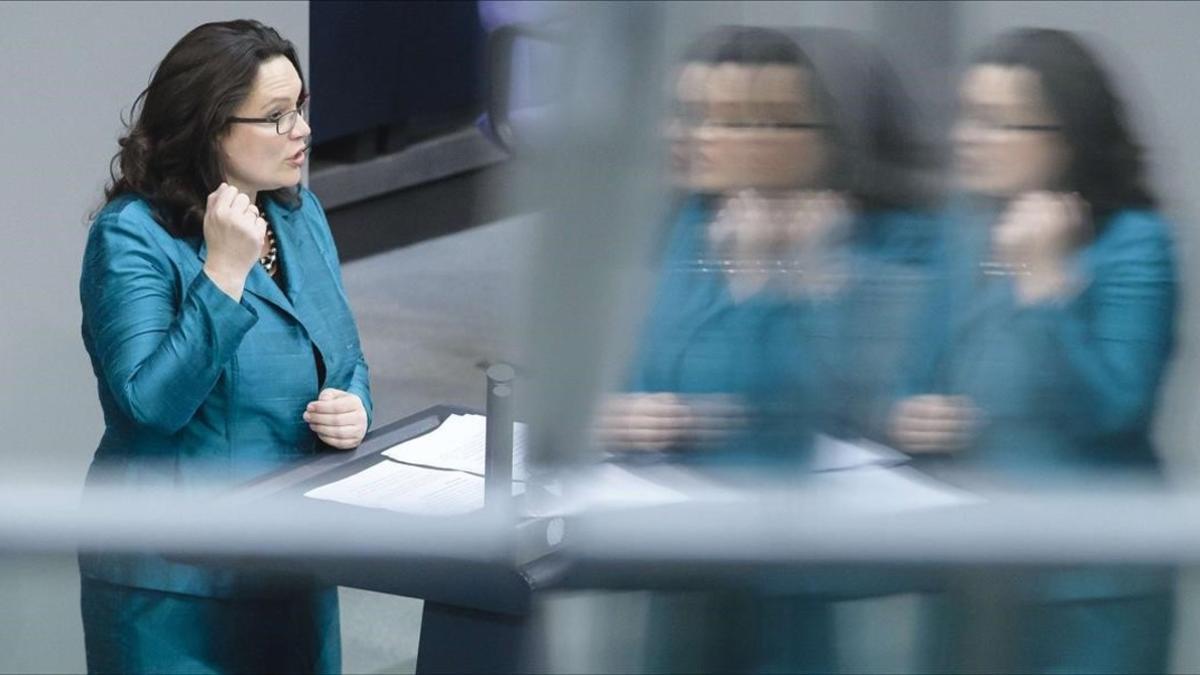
[79,184,372,597]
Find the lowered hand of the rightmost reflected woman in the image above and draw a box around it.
[888,395,979,454]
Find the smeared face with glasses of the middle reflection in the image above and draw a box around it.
[671,64,829,192]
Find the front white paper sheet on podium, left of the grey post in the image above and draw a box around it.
[305,460,524,515]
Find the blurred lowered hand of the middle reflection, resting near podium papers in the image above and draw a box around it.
[595,393,745,452]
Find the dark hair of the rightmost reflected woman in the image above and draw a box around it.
[974,28,1156,225]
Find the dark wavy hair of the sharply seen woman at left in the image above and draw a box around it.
[104,20,307,237]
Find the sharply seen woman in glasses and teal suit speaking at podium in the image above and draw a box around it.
[79,20,371,673]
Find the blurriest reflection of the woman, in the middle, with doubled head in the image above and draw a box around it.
[598,26,935,673]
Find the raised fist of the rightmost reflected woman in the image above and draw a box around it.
[991,192,1092,304]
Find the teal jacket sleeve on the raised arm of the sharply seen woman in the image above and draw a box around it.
[80,207,258,435]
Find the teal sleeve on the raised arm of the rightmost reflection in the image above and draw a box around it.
[1015,214,1176,437]
